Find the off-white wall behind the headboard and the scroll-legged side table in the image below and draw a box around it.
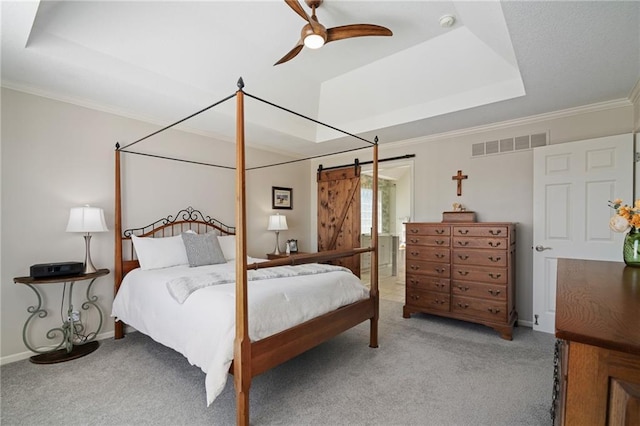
[0,88,311,363]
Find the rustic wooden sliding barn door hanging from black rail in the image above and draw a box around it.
[318,166,360,276]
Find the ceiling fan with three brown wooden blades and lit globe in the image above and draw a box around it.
[274,0,393,65]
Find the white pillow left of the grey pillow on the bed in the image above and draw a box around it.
[131,235,189,270]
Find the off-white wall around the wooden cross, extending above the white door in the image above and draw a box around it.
[310,102,634,324]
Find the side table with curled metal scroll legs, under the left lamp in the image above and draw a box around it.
[13,269,109,364]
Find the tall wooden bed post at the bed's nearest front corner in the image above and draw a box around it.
[233,78,251,425]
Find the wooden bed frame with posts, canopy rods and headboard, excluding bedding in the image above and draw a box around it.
[114,78,379,425]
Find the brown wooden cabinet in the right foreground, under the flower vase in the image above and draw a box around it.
[552,259,640,425]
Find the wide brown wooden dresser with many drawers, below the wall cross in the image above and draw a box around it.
[403,222,518,340]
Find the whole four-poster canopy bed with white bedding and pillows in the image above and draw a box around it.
[113,79,379,424]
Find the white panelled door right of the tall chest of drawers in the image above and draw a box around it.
[533,134,634,333]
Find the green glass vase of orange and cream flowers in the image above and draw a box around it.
[609,199,640,268]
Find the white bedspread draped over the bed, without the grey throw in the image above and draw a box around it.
[112,259,369,405]
